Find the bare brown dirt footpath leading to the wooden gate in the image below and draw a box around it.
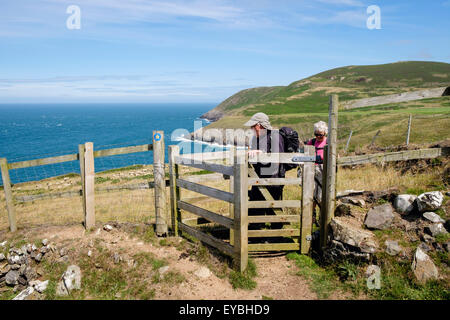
[1,225,324,300]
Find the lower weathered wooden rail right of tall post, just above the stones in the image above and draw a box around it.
[338,148,448,166]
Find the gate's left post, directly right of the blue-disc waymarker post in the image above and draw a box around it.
[169,145,181,236]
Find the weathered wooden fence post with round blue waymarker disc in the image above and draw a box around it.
[153,131,167,236]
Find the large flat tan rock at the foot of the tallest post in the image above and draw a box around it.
[330,218,377,253]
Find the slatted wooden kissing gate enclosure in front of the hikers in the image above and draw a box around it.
[169,146,315,271]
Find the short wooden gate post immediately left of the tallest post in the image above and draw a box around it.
[300,145,315,254]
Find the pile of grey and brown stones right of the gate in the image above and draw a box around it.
[324,191,450,283]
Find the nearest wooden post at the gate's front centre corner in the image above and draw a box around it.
[233,151,248,272]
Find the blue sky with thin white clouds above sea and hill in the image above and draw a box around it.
[0,0,450,103]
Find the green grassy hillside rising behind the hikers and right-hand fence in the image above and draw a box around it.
[201,61,450,151]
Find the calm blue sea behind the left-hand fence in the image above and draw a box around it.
[0,103,225,184]
